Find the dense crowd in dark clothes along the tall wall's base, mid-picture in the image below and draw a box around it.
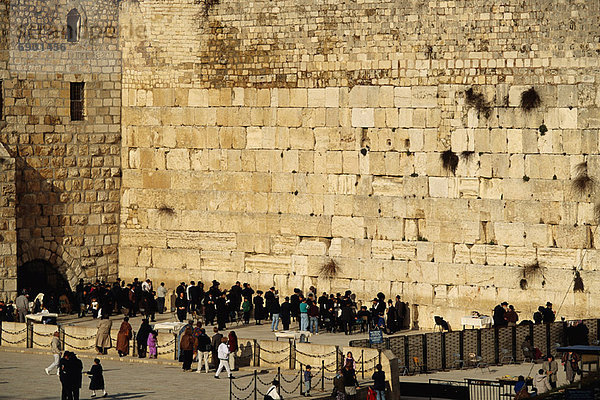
[159,280,410,334]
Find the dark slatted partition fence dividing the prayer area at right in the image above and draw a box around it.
[350,319,600,372]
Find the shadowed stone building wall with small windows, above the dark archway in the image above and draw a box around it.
[0,0,121,296]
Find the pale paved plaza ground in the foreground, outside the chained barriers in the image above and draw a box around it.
[0,349,576,400]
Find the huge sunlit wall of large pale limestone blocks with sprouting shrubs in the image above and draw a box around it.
[119,0,600,326]
